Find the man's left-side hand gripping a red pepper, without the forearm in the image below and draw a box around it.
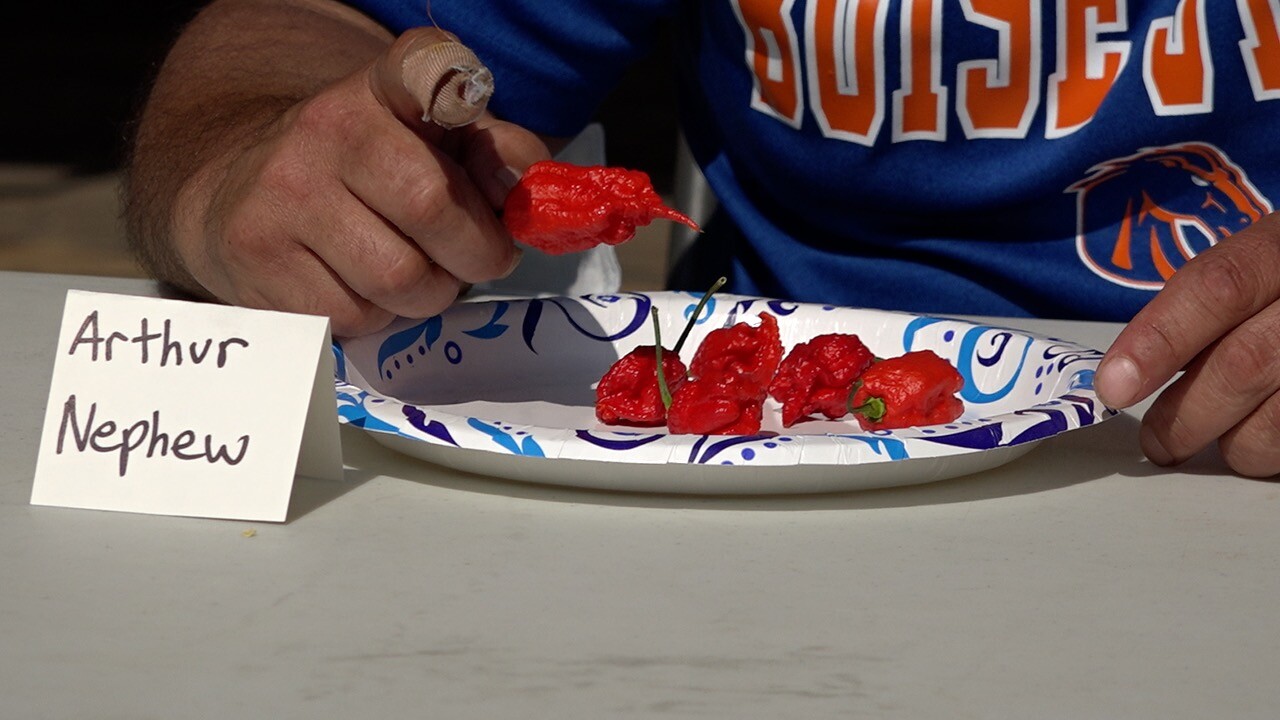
[131,5,548,336]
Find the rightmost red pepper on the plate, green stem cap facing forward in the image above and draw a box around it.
[849,350,964,430]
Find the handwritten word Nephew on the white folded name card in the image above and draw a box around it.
[56,392,250,478]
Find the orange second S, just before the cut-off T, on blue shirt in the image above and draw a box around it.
[1142,0,1213,115]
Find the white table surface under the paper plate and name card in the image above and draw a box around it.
[0,273,1280,720]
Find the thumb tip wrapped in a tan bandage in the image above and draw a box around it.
[369,27,493,129]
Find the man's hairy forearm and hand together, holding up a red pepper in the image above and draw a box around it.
[131,0,548,336]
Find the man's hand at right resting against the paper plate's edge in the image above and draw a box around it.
[1096,213,1280,478]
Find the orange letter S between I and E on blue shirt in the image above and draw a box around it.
[956,0,1041,137]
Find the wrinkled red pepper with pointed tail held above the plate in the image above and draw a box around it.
[502,160,698,255]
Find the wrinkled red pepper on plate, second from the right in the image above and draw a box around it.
[769,333,874,428]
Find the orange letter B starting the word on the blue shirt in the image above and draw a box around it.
[732,0,804,128]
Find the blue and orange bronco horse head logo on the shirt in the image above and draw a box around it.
[1066,142,1271,290]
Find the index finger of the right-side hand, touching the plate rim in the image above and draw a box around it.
[1094,213,1280,407]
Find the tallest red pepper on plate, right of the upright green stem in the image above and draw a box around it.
[667,313,782,434]
